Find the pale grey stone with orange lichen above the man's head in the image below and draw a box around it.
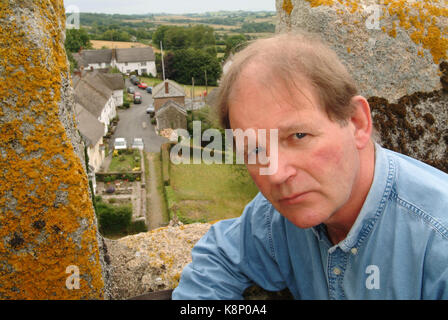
[276,0,448,103]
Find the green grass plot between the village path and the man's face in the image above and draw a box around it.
[167,164,258,222]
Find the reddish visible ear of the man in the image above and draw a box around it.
[350,96,372,149]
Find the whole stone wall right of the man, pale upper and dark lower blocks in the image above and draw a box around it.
[276,0,448,172]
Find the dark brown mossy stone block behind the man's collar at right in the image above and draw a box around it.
[369,90,448,173]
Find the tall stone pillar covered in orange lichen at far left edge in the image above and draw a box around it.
[0,0,105,299]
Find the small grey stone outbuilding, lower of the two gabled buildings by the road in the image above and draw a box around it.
[155,100,187,132]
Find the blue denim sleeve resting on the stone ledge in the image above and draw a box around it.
[172,192,286,300]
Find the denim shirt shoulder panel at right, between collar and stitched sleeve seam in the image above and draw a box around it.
[386,150,448,239]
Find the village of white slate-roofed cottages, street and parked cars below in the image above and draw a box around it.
[72,47,191,230]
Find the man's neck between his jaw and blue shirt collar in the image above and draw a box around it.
[325,142,375,244]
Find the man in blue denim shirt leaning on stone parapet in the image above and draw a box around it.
[173,34,448,299]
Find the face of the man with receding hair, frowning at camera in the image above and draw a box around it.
[229,67,360,228]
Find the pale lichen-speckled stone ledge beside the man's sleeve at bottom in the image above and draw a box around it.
[105,223,210,299]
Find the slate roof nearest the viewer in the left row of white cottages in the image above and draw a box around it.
[75,103,104,147]
